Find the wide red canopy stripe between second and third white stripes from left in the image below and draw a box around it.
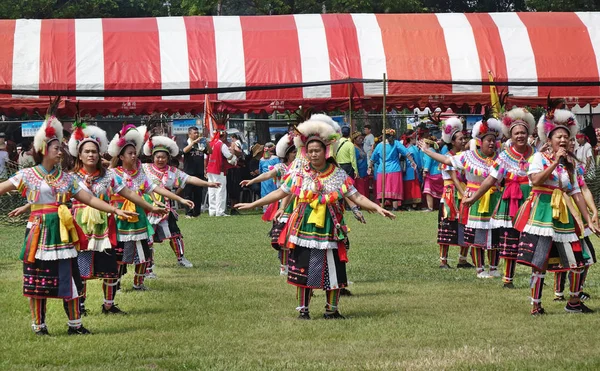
[102,18,162,100]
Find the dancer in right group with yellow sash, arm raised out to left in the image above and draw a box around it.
[420,115,502,278]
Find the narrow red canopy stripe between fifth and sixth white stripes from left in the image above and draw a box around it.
[321,14,364,98]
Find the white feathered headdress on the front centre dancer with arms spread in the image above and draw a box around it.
[294,114,340,157]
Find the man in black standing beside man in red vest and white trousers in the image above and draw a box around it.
[183,126,210,218]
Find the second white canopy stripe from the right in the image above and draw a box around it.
[490,13,538,97]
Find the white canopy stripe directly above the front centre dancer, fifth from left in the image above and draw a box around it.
[294,14,331,98]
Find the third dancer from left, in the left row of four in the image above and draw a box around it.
[108,125,194,291]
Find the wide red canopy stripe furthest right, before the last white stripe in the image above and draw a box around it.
[519,13,600,97]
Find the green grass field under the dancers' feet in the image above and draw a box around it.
[0,212,600,370]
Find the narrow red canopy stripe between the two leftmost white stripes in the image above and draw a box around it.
[40,19,76,90]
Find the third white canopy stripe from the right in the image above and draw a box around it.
[436,13,482,93]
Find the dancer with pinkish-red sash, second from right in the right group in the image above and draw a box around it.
[463,108,535,289]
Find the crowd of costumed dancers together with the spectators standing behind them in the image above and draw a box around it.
[0,102,599,335]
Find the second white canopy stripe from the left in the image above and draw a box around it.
[75,19,104,100]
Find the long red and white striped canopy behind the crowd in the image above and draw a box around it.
[0,13,600,113]
